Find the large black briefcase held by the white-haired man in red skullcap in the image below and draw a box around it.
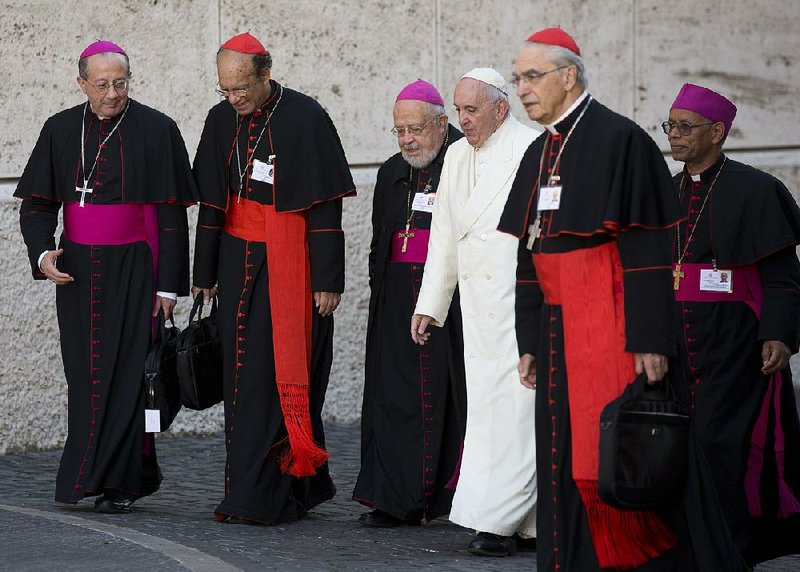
[597,374,689,510]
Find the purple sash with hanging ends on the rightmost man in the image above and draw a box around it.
[675,264,800,518]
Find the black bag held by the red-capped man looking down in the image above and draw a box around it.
[177,293,222,410]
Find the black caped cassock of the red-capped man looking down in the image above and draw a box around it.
[193,81,355,524]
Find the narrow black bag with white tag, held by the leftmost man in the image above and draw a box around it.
[144,311,181,431]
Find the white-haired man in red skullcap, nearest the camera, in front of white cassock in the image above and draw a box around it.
[499,28,687,572]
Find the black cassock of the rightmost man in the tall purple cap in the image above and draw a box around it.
[673,156,800,567]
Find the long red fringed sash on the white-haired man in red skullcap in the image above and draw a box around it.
[533,243,677,569]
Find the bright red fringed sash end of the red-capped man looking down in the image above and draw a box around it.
[278,383,328,477]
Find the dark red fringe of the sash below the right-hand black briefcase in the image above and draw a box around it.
[576,481,678,569]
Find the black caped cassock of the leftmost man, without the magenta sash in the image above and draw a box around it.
[15,100,196,503]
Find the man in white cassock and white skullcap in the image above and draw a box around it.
[411,68,539,556]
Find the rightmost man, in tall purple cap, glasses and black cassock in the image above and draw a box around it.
[662,83,800,570]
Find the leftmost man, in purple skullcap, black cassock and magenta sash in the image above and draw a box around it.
[15,41,196,513]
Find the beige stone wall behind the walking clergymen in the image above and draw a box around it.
[0,0,800,454]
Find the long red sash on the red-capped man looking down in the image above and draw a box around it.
[225,199,328,477]
